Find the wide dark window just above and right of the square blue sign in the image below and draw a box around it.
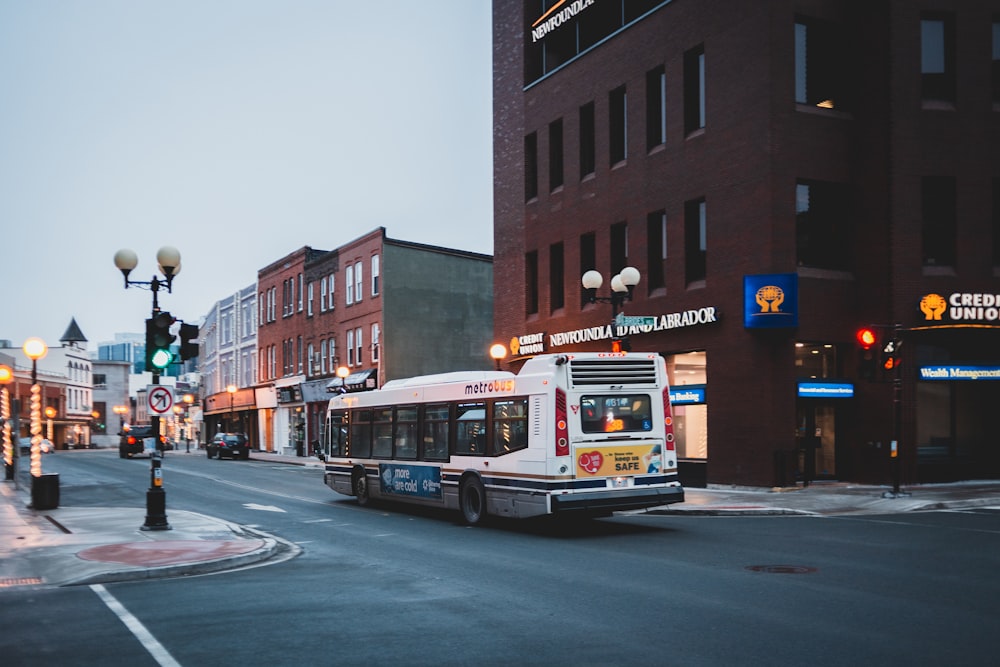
[795,181,854,271]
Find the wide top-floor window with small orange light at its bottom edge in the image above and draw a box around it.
[795,19,851,111]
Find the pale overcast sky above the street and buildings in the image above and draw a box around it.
[0,0,493,350]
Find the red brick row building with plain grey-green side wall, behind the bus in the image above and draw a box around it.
[248,227,493,454]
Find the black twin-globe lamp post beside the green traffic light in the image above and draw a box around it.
[114,246,181,530]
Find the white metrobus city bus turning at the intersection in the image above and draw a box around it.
[322,352,684,524]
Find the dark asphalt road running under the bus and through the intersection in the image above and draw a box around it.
[0,452,1000,667]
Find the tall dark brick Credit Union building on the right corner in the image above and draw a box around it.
[493,0,1000,485]
